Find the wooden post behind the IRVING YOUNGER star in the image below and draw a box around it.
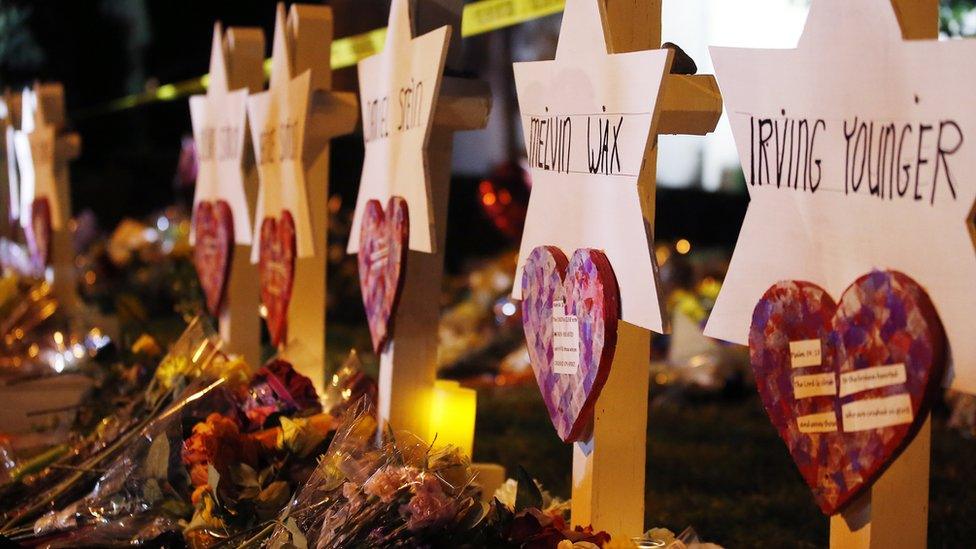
[830,5,939,549]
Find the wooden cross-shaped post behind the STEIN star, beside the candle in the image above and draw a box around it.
[377,0,491,437]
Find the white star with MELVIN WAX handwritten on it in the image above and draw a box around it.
[514,0,669,332]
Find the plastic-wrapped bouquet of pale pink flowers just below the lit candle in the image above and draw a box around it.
[268,399,487,548]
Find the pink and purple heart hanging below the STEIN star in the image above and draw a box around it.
[358,196,410,353]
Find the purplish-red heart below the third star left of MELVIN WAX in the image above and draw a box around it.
[193,200,234,316]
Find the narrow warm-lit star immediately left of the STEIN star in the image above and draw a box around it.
[247,4,316,263]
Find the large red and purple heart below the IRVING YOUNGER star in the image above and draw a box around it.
[749,271,945,515]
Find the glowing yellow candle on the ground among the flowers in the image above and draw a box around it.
[428,380,478,456]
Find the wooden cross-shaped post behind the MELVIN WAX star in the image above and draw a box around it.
[572,0,722,546]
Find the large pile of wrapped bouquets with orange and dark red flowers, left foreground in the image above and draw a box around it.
[5,340,366,547]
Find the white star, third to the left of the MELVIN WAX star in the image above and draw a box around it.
[190,23,263,244]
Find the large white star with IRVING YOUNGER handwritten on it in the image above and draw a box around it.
[705,0,976,392]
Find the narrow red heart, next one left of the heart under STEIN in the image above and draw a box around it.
[258,211,295,347]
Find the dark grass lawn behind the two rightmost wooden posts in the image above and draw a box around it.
[474,385,976,548]
